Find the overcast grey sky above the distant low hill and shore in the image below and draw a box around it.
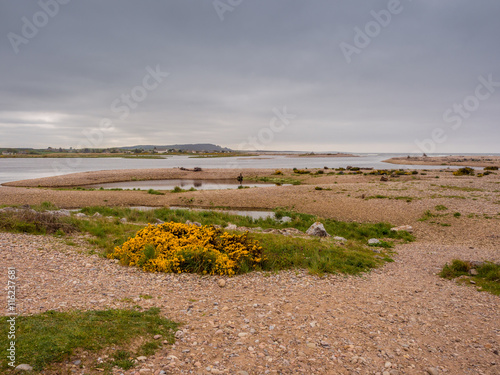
[0,0,500,153]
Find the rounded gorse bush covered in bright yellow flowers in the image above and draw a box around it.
[108,222,263,276]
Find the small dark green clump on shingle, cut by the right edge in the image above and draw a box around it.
[439,259,500,295]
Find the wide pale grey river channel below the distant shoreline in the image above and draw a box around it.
[0,154,494,184]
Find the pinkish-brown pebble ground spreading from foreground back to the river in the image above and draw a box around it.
[0,170,500,375]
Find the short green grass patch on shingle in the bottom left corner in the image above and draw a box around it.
[0,308,178,371]
